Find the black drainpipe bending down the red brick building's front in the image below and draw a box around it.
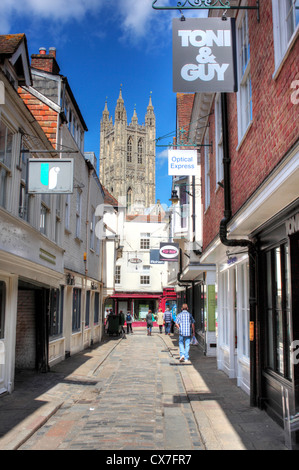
[219,93,257,406]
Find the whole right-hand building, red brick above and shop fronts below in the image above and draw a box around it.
[171,0,299,423]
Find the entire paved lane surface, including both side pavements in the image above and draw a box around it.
[0,328,286,452]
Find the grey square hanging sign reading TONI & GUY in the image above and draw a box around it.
[172,18,237,93]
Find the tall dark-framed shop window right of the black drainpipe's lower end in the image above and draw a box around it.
[265,243,292,379]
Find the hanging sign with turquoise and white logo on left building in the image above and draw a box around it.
[27,158,74,194]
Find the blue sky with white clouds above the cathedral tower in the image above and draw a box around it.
[0,0,206,206]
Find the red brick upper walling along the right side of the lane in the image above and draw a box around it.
[201,0,299,249]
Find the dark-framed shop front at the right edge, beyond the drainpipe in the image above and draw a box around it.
[256,200,299,423]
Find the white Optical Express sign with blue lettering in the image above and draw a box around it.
[168,150,197,176]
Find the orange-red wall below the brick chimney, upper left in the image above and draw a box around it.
[18,88,57,148]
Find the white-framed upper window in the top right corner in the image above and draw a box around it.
[272,0,299,69]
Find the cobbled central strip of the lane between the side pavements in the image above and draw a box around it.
[20,331,203,450]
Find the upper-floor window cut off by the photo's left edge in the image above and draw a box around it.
[0,121,13,208]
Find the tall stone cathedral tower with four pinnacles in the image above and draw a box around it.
[100,90,156,214]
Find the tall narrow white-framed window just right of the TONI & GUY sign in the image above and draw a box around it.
[237,11,252,142]
